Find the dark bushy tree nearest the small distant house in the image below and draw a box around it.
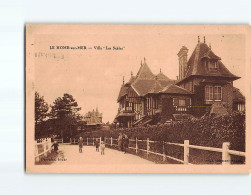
[50,93,82,137]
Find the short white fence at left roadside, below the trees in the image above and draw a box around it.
[35,138,51,162]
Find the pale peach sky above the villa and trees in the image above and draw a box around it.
[31,25,246,122]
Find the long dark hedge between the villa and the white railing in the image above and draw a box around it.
[76,112,246,163]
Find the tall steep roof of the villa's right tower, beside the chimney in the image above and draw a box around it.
[179,43,239,80]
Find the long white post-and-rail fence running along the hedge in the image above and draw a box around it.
[70,137,246,164]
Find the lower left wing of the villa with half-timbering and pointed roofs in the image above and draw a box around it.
[114,60,191,127]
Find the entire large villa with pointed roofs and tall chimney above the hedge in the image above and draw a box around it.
[114,36,245,127]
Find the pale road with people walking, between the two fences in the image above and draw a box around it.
[52,144,154,165]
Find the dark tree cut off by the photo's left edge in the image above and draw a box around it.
[35,92,49,136]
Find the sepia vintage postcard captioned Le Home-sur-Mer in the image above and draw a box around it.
[25,24,251,173]
